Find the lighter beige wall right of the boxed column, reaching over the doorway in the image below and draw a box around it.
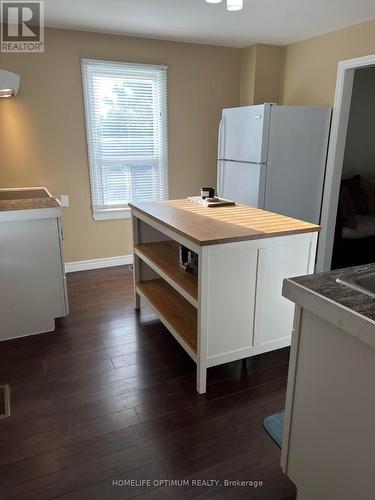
[282,20,375,106]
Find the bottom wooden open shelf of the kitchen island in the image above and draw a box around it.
[136,279,197,361]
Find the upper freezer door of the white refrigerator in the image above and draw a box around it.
[218,104,271,163]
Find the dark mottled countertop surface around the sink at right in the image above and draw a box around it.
[288,263,375,321]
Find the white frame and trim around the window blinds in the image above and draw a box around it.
[80,58,169,221]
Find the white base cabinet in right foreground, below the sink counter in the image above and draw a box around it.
[281,281,375,500]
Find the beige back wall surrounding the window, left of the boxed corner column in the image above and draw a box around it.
[0,29,241,261]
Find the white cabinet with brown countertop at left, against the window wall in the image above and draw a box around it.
[0,188,68,341]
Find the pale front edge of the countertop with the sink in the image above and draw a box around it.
[282,278,375,349]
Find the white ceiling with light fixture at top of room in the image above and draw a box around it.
[45,0,375,47]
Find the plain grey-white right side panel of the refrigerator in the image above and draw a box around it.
[265,106,331,224]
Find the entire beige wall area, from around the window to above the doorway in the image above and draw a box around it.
[0,20,375,261]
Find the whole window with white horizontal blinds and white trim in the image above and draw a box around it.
[82,59,168,220]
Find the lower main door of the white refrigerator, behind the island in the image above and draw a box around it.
[217,160,266,208]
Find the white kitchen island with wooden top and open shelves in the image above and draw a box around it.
[130,200,320,393]
